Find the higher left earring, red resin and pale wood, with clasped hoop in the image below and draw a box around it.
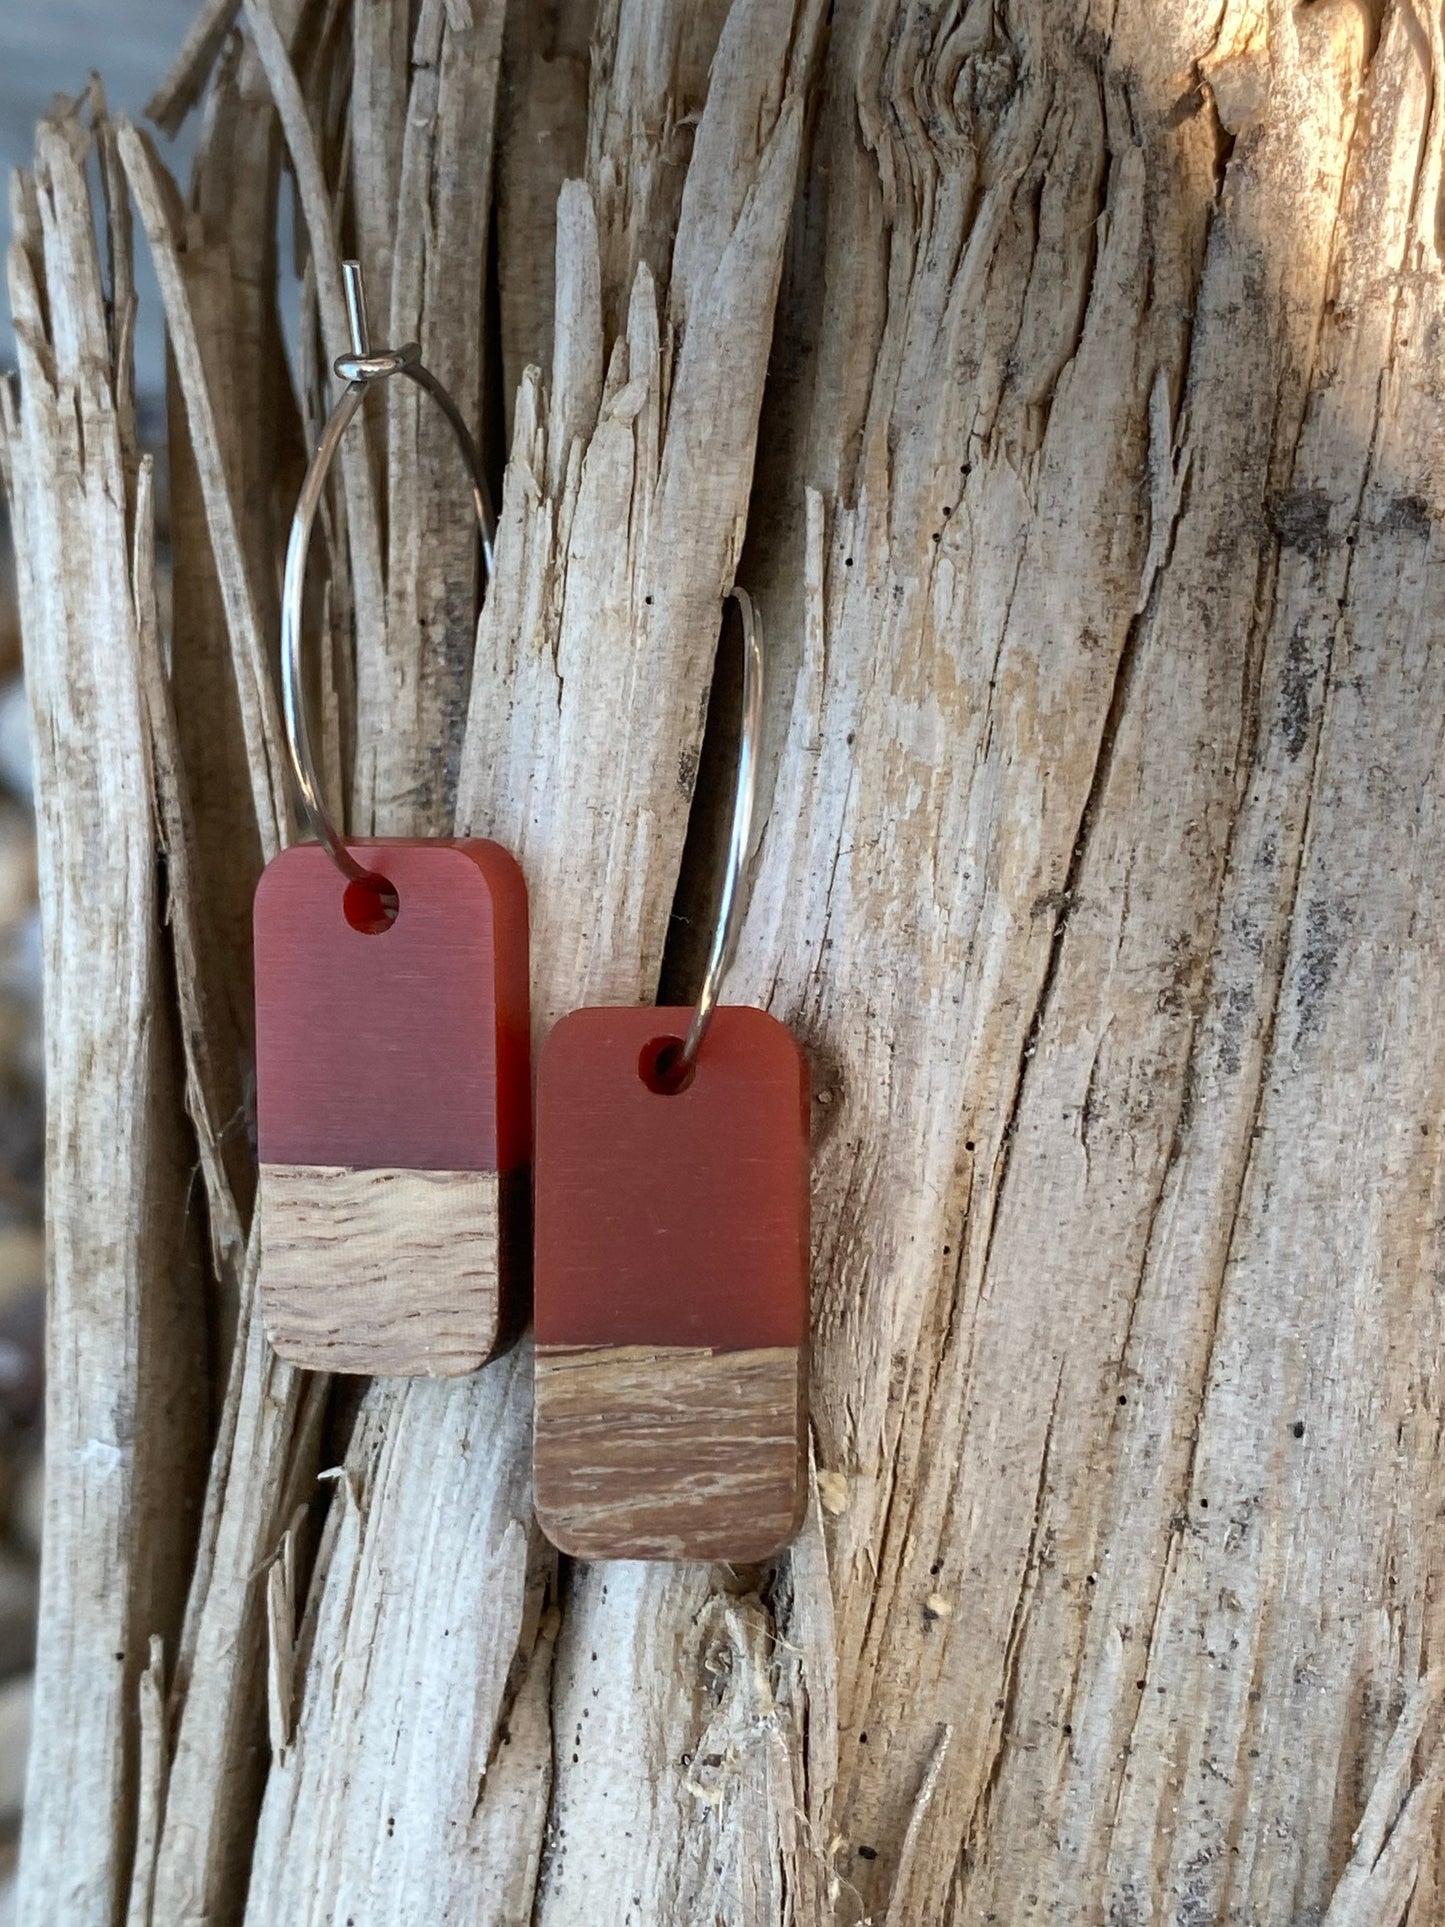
[254,262,532,1378]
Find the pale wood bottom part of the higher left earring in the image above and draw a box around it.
[256,1164,501,1378]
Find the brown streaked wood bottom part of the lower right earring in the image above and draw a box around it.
[532,1345,807,1565]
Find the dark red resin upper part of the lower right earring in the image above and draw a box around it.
[534,1006,809,1351]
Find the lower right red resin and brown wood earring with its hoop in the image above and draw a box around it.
[534,590,809,1563]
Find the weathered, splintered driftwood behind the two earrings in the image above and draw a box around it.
[4,0,1445,1927]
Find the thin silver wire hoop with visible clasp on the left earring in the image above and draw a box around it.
[281,260,495,883]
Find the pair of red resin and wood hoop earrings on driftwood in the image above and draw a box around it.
[254,264,809,1563]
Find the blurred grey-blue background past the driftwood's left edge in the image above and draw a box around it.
[0,0,195,1903]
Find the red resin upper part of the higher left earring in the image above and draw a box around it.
[254,840,532,1174]
